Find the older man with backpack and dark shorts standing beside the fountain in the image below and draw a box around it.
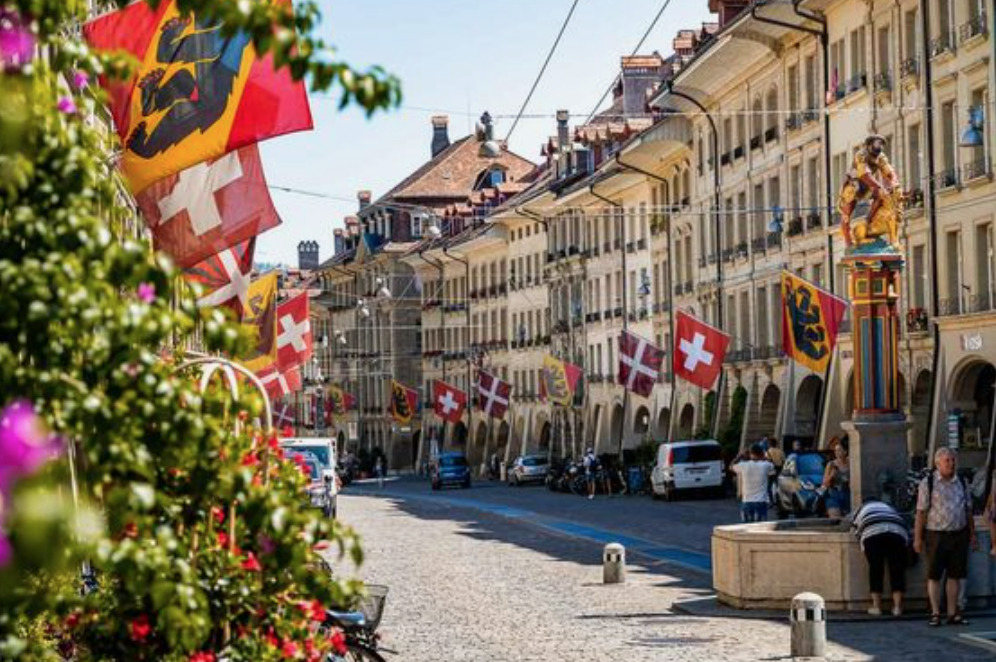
[913,447,979,626]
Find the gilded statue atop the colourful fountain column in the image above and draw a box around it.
[837,135,905,252]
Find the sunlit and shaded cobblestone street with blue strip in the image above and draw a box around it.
[340,481,996,662]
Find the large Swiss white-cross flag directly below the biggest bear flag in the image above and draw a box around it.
[135,145,280,268]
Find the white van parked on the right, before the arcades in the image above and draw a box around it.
[650,439,723,501]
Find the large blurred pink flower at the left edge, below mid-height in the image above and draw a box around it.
[0,400,62,501]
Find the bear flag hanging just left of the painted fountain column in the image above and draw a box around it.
[782,271,847,373]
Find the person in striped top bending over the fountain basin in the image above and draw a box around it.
[851,499,910,616]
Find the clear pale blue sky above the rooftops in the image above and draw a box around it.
[256,0,711,265]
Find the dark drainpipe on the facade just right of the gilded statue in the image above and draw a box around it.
[918,0,941,467]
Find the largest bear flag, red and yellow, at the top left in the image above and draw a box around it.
[83,0,312,193]
